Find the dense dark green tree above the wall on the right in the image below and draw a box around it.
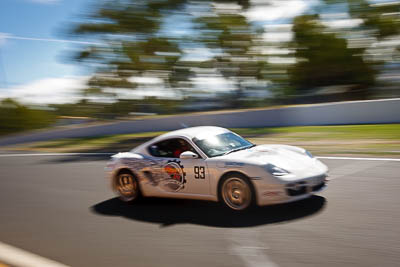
[289,15,375,93]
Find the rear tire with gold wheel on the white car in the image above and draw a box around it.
[114,170,140,202]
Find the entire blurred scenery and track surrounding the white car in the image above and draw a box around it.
[0,0,400,267]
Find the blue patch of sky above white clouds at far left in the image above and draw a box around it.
[0,0,88,88]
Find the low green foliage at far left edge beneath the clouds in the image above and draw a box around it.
[0,99,55,135]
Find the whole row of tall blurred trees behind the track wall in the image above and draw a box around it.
[71,0,400,109]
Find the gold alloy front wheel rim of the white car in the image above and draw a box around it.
[222,177,251,210]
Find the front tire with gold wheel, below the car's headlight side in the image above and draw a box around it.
[219,174,254,211]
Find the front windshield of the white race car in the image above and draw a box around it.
[193,132,254,158]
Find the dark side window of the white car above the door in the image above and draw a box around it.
[148,138,197,158]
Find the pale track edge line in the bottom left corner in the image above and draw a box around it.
[0,242,68,267]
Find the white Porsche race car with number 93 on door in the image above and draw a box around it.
[106,126,328,211]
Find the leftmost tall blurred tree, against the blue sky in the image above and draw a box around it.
[71,0,186,100]
